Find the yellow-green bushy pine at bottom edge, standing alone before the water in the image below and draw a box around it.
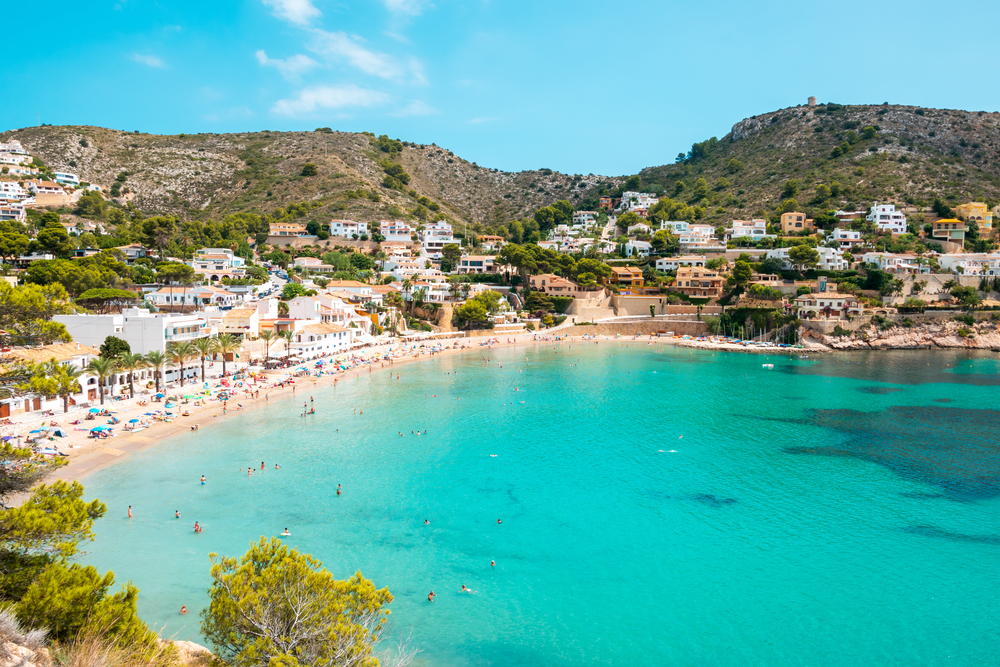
[201,537,392,667]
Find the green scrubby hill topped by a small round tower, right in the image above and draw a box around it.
[640,104,1000,219]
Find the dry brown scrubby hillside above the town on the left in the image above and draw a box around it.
[0,126,621,232]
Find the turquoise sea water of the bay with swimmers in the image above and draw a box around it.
[84,343,1000,667]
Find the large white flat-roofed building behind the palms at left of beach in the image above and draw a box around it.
[52,308,216,354]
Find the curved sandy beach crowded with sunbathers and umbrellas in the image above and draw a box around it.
[0,332,688,481]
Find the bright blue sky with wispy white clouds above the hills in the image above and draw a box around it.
[7,0,1000,176]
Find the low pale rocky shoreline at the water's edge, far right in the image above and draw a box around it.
[818,321,1000,350]
